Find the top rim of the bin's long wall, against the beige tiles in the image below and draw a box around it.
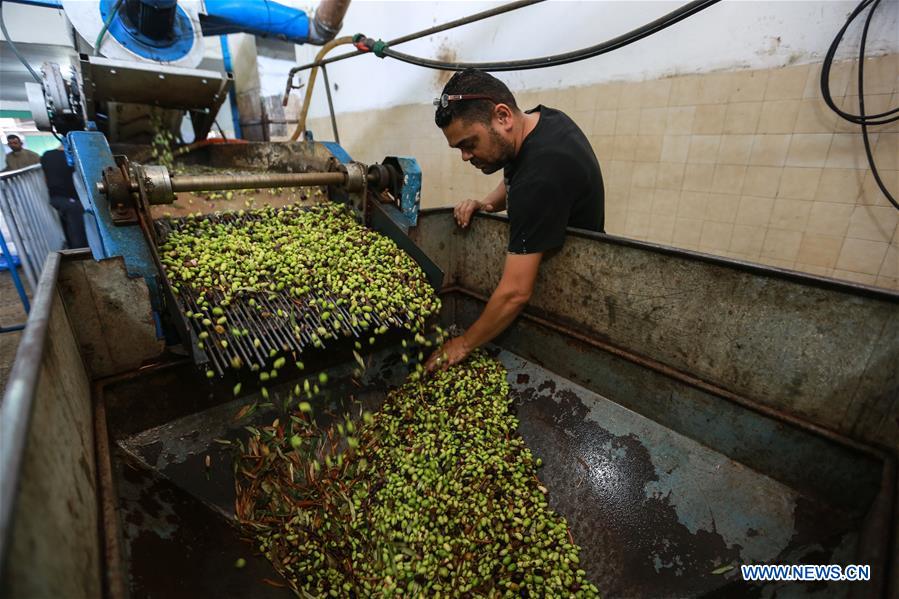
[419,207,899,304]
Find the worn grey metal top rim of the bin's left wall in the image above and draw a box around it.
[0,252,62,577]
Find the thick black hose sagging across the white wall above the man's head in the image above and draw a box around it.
[382,0,720,72]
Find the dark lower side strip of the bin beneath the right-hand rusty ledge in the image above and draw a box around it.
[444,293,889,514]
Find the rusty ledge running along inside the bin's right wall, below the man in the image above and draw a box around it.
[440,285,899,597]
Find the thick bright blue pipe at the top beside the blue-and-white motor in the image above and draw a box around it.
[200,0,309,44]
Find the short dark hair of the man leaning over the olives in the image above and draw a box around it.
[434,69,518,129]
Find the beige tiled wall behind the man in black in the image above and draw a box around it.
[310,54,899,290]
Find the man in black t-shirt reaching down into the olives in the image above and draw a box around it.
[426,69,605,370]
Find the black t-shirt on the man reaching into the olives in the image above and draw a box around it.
[503,106,605,254]
